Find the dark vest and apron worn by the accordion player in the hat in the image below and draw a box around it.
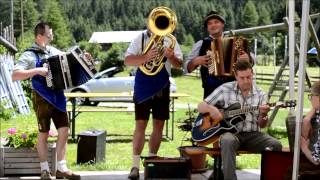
[199,37,235,99]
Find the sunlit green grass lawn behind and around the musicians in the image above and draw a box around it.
[0,67,320,171]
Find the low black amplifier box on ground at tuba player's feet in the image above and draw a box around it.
[143,157,191,179]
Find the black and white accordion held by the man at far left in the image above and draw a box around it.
[44,46,97,90]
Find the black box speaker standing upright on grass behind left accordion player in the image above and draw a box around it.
[77,131,106,164]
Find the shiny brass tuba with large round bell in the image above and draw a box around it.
[139,6,177,76]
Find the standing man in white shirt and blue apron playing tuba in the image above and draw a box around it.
[124,8,182,179]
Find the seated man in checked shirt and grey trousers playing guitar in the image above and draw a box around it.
[198,61,282,180]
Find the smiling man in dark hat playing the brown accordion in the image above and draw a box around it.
[184,11,253,98]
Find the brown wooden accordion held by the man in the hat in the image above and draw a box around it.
[207,36,249,76]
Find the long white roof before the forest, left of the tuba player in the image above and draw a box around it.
[89,31,143,44]
